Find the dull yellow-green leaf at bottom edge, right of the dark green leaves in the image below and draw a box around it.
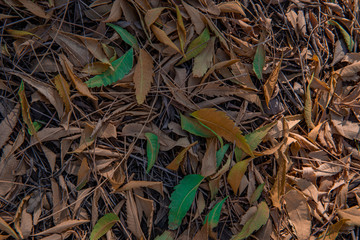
[231,202,269,240]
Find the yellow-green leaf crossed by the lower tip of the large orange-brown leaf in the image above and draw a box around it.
[235,122,276,162]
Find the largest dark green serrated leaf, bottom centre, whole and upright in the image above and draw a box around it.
[169,174,204,230]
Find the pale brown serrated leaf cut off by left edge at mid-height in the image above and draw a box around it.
[0,104,20,149]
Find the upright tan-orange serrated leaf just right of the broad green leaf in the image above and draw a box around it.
[133,49,154,104]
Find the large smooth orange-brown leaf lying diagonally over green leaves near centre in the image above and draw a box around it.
[191,108,254,156]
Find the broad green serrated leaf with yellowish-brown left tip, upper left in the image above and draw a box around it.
[85,48,133,88]
